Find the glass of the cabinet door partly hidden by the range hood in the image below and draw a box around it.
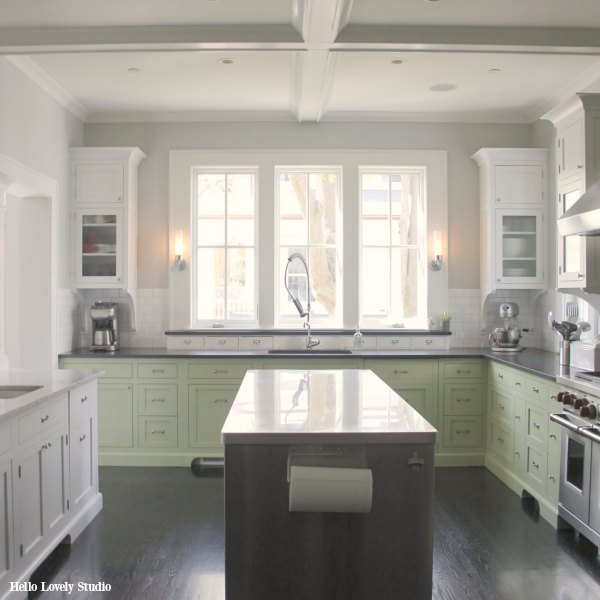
[557,179,586,287]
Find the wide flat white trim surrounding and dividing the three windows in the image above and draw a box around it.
[169,149,451,330]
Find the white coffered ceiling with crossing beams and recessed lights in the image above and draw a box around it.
[0,0,600,122]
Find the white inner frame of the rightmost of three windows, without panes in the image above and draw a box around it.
[358,165,429,328]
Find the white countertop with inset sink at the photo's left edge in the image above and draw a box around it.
[0,369,104,422]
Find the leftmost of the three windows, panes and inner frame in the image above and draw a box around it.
[192,167,257,326]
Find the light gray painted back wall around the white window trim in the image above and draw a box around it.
[84,122,552,288]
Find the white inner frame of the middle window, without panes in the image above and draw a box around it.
[273,165,344,329]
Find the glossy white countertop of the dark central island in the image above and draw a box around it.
[222,369,437,445]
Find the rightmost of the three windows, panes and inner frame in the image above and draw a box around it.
[360,167,427,327]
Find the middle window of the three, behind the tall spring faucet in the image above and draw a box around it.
[275,167,342,326]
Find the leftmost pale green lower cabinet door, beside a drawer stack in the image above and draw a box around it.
[98,383,134,448]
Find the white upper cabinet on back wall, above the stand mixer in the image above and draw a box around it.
[472,148,548,305]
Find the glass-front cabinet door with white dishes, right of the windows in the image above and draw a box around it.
[496,209,544,286]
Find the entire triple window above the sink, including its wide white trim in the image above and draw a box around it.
[169,149,448,330]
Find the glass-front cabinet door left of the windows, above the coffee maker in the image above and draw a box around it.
[76,208,123,285]
